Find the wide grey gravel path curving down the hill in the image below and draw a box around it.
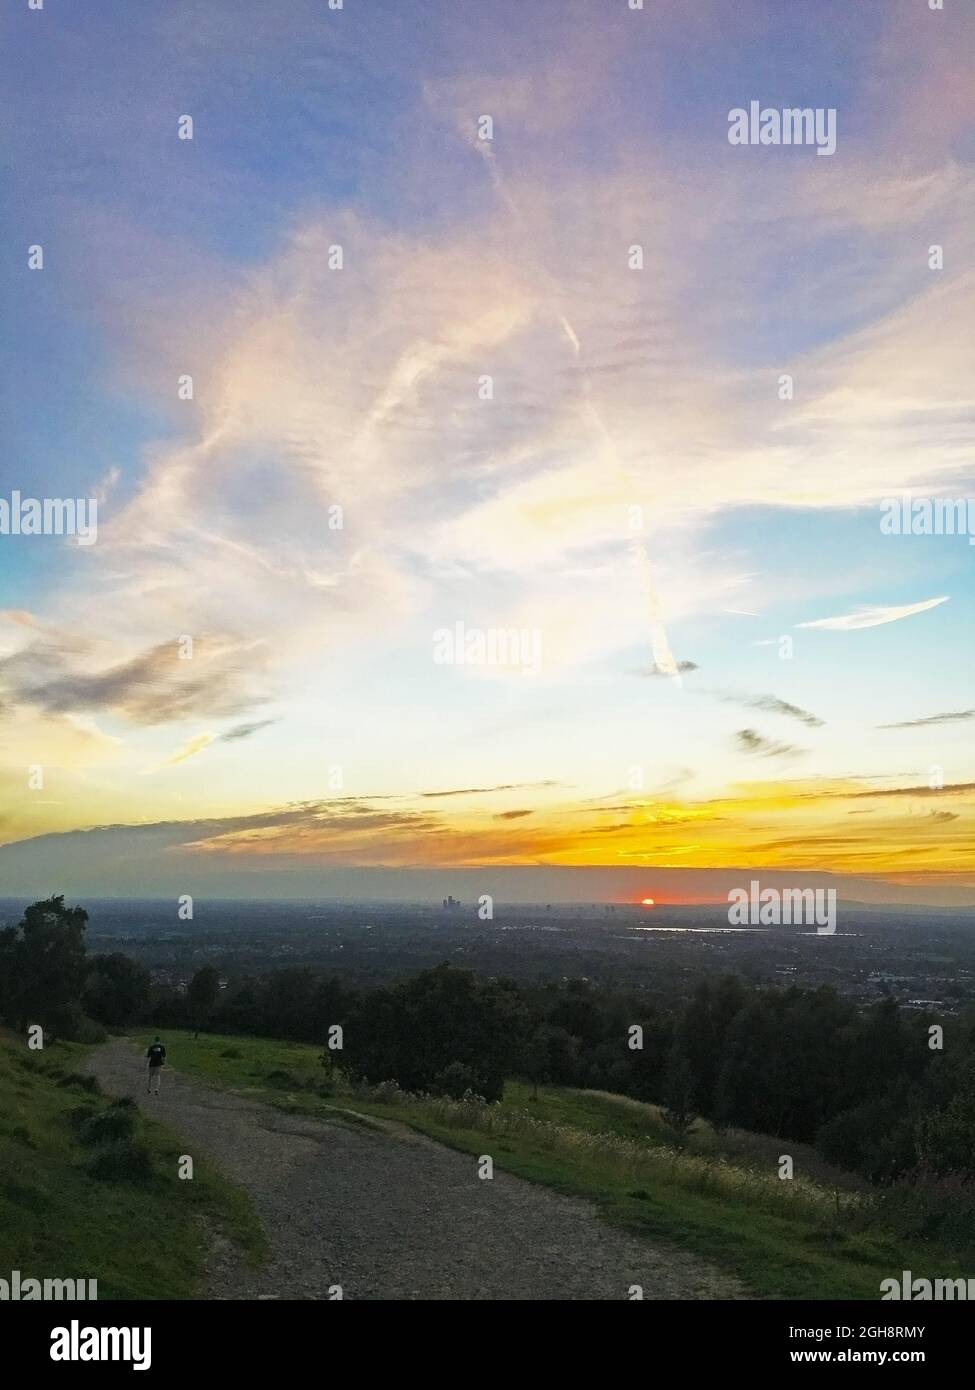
[89,1040,747,1300]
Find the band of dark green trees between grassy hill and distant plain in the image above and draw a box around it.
[0,898,975,1183]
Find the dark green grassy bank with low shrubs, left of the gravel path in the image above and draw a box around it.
[0,1030,263,1298]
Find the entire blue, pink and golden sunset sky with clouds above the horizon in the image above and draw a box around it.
[0,0,975,902]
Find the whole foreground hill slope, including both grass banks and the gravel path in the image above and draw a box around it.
[0,1033,965,1300]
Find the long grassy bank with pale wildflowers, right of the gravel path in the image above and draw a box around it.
[146,1031,965,1298]
